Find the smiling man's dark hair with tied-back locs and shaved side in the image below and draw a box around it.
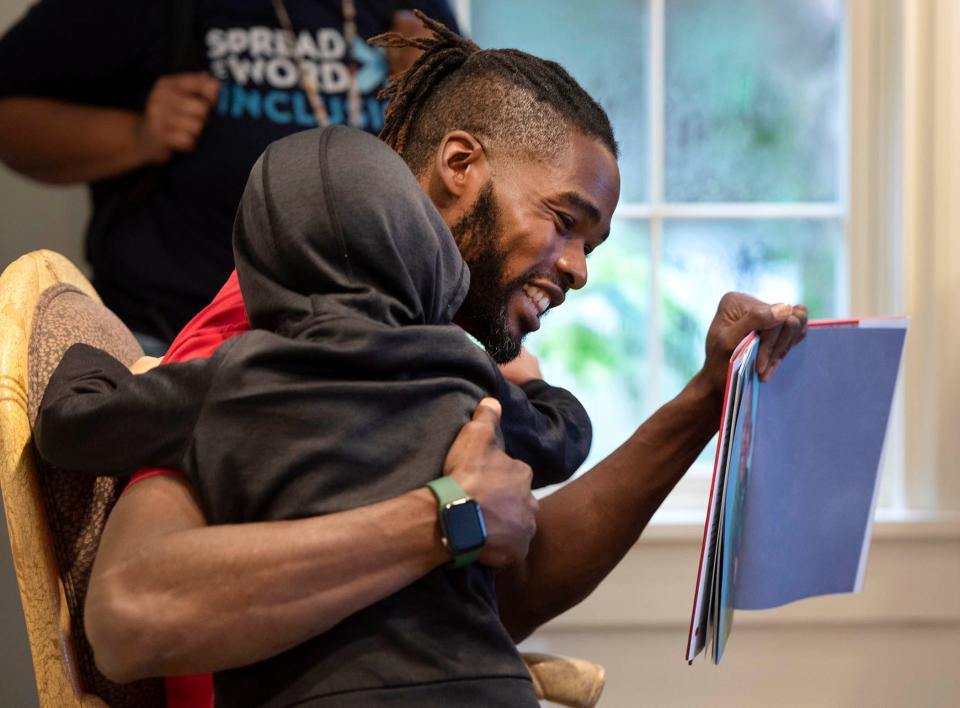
[370,10,618,175]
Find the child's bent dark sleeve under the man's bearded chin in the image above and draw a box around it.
[499,377,593,487]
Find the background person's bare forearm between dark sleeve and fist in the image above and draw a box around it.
[0,97,146,184]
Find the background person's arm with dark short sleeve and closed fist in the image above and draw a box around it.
[0,0,218,184]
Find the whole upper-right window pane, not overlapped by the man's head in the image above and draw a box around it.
[665,0,843,202]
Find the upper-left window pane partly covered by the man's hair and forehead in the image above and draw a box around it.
[470,0,648,202]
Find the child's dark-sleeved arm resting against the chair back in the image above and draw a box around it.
[33,344,213,475]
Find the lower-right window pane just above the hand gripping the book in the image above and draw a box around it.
[661,219,843,398]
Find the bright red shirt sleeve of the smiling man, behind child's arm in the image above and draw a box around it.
[124,271,250,491]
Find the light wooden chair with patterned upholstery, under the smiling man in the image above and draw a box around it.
[0,251,604,708]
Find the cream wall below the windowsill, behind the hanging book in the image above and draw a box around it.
[525,520,960,708]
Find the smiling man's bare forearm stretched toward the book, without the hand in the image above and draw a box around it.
[497,375,722,640]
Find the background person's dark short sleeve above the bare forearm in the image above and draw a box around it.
[0,0,159,103]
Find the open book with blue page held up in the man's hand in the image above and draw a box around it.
[686,318,907,663]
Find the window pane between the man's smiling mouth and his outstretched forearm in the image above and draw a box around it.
[526,220,650,476]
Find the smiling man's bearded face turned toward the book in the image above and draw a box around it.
[451,133,620,363]
